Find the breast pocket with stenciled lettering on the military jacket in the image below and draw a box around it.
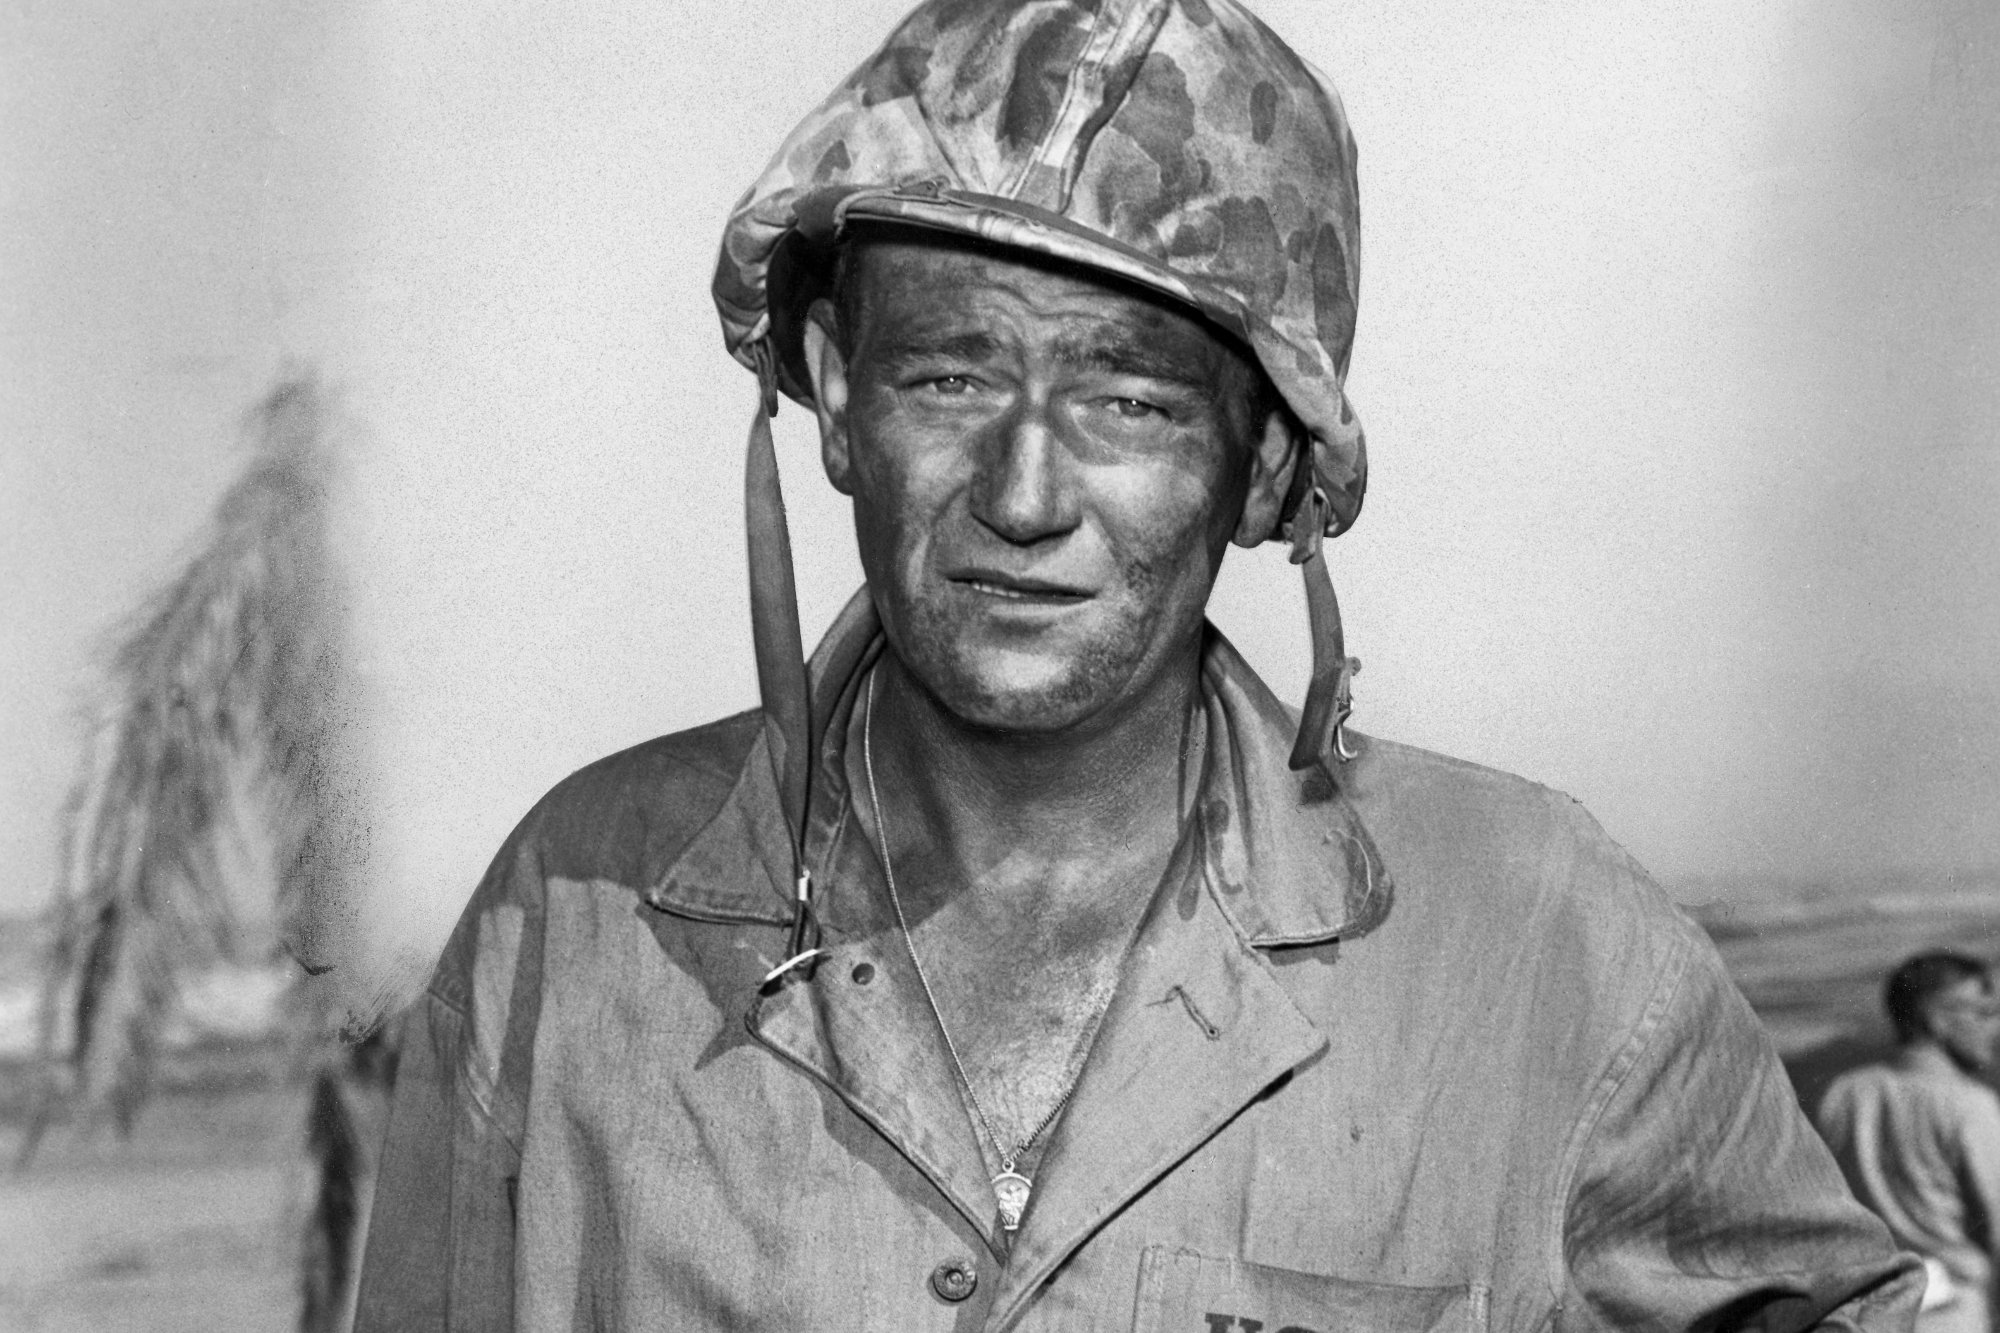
[1132,1245,1486,1333]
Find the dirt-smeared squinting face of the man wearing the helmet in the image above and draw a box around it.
[806,240,1284,733]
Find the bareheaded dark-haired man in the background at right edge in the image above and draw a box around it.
[1818,951,2000,1333]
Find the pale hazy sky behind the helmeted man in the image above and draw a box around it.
[0,0,2000,976]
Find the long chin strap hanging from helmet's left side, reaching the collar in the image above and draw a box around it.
[744,338,826,991]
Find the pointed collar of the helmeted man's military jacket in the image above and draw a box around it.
[646,586,1394,949]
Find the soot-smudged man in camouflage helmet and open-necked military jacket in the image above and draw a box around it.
[360,0,1918,1333]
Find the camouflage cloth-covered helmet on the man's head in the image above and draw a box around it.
[714,0,1366,544]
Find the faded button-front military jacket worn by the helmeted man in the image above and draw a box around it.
[358,596,1922,1333]
